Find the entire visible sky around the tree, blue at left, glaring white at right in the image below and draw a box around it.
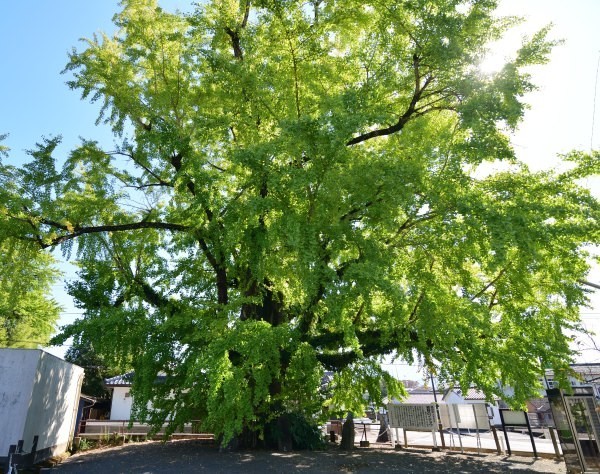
[0,0,600,375]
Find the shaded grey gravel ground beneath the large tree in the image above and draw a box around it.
[45,441,566,474]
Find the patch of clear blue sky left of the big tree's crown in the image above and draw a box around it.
[0,0,117,161]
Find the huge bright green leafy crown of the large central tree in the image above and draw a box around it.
[0,0,600,440]
